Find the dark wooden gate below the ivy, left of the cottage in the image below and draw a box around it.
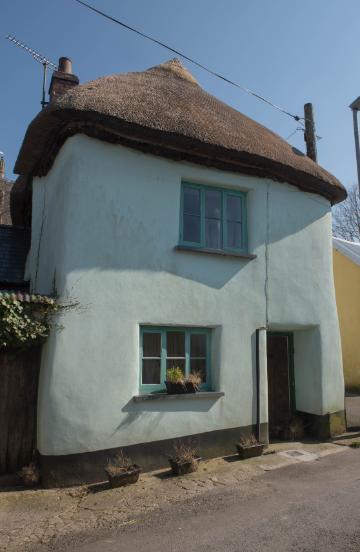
[0,347,40,474]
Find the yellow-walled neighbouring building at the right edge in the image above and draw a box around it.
[333,238,360,393]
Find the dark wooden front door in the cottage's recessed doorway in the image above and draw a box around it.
[267,334,292,437]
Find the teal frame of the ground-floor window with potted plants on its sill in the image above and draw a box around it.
[140,326,211,393]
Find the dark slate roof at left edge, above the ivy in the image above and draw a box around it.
[0,225,30,287]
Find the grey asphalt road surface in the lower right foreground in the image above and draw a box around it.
[71,449,360,552]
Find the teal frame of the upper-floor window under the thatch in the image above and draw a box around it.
[179,181,248,254]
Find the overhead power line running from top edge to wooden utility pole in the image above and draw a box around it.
[75,0,304,121]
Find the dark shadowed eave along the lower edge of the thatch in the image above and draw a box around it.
[14,108,347,204]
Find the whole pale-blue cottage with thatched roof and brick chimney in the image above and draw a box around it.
[15,59,346,484]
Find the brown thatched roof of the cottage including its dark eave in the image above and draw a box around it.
[15,60,346,203]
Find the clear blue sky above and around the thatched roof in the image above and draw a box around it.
[0,0,360,186]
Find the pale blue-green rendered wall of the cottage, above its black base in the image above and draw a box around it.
[29,135,343,454]
